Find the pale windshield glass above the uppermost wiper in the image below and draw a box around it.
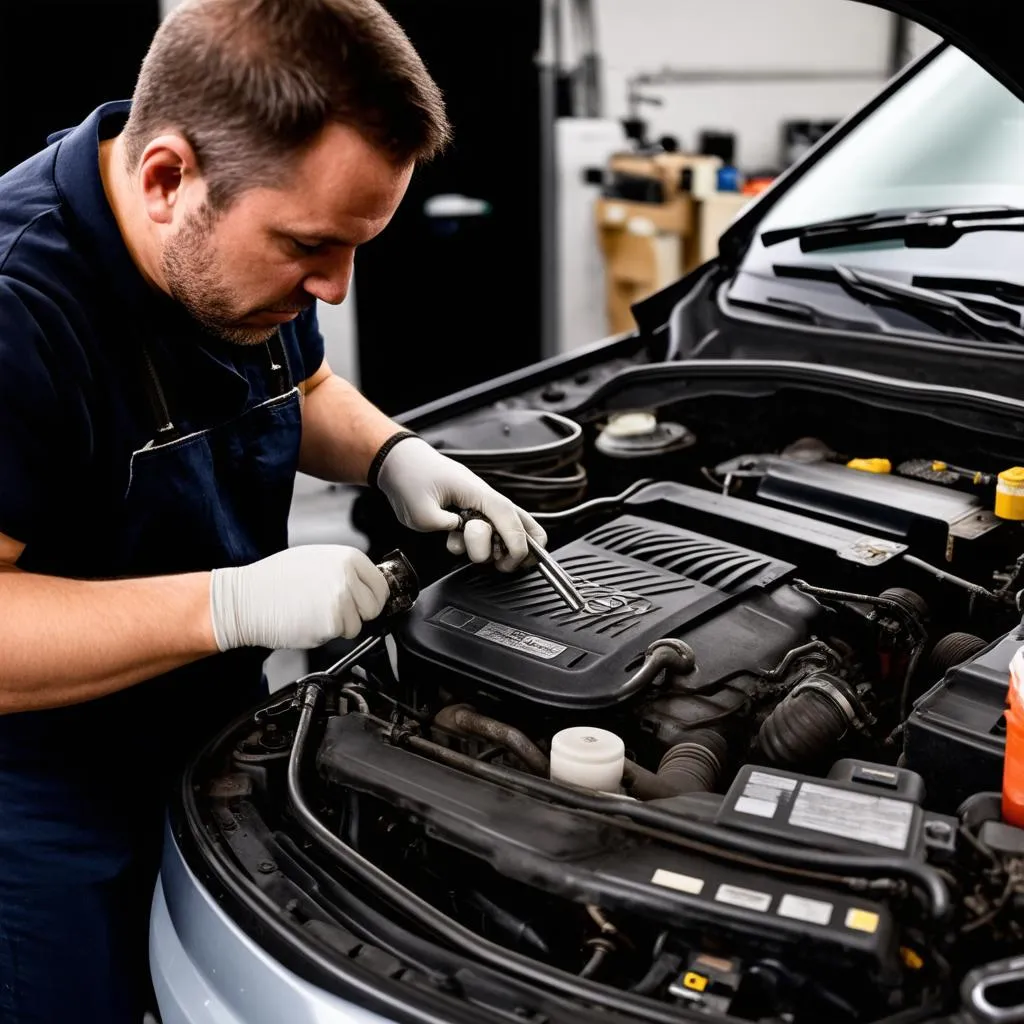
[759,47,1024,235]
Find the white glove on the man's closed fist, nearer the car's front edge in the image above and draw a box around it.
[210,544,390,650]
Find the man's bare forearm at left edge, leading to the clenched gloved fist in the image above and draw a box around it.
[0,568,217,714]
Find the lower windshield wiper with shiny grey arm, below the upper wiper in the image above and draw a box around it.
[774,263,1024,345]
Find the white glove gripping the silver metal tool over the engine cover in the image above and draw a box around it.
[377,437,548,572]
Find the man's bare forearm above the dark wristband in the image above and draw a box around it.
[299,374,400,483]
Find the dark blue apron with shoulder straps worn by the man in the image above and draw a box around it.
[0,336,301,1024]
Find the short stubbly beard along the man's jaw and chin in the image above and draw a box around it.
[161,203,278,345]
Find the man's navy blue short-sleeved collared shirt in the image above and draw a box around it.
[0,102,324,579]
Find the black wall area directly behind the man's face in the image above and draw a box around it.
[355,0,541,413]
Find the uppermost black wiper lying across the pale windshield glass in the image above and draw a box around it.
[761,206,1024,253]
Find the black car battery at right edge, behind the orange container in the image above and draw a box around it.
[904,628,1024,814]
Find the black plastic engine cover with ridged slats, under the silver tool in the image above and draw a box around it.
[398,515,811,709]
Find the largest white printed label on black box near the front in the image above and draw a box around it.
[790,782,913,850]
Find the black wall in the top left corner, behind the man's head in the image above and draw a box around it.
[0,0,160,173]
